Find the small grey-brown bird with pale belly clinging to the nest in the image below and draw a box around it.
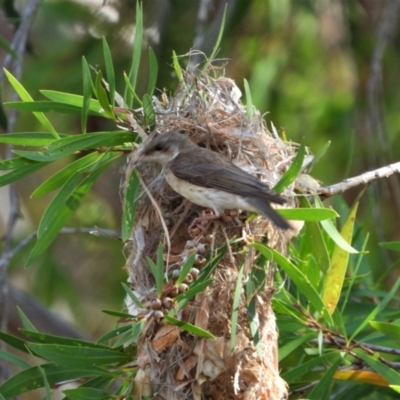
[132,131,291,230]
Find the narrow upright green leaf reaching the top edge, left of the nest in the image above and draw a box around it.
[124,2,143,108]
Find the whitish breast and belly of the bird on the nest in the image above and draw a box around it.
[165,170,257,215]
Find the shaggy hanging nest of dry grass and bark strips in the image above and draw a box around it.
[126,66,297,400]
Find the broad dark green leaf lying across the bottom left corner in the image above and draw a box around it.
[0,364,110,399]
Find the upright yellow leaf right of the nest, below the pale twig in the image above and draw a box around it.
[322,192,363,315]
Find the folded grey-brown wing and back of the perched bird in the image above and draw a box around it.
[168,147,286,204]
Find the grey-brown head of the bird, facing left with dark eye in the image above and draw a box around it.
[133,132,196,167]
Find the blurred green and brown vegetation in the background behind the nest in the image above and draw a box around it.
[0,0,400,398]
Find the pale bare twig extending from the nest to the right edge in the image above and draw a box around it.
[317,162,400,197]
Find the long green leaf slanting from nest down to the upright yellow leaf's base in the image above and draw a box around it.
[251,243,333,325]
